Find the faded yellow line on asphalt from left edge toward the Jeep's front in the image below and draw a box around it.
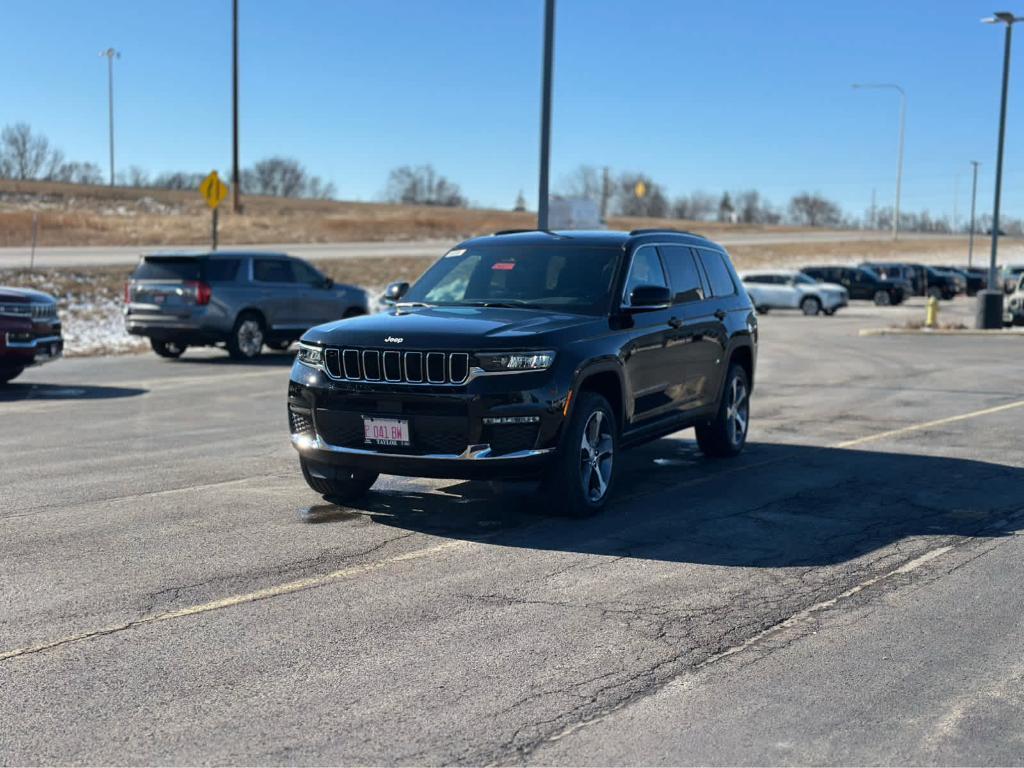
[0,542,471,662]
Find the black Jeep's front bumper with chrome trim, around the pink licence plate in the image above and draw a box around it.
[288,362,565,479]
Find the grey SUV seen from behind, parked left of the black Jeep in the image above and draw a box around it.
[124,251,370,359]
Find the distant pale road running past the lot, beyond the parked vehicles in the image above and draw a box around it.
[0,230,948,268]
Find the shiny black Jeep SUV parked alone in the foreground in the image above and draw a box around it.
[288,229,758,515]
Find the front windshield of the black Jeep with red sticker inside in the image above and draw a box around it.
[404,245,622,314]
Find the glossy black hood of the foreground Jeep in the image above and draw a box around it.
[302,306,608,351]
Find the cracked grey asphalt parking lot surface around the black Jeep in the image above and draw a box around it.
[0,299,1024,764]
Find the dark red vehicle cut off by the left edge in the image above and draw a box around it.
[0,286,63,384]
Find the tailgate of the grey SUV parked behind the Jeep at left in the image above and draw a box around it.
[126,256,206,321]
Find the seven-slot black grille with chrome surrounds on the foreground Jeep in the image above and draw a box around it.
[324,347,469,384]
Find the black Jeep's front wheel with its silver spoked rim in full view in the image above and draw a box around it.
[541,391,618,517]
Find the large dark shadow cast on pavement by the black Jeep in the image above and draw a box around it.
[335,439,1024,567]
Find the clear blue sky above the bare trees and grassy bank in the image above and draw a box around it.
[0,0,1024,219]
